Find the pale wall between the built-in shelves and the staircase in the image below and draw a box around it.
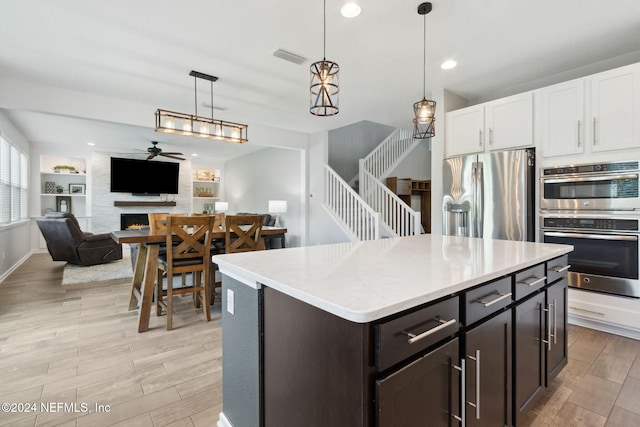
[224,148,306,247]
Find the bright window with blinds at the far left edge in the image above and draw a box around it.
[0,136,29,224]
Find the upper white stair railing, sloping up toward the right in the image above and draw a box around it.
[360,129,420,180]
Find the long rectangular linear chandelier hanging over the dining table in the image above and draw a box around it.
[156,71,248,144]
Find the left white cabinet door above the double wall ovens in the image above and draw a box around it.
[536,79,585,157]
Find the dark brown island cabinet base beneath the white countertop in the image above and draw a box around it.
[218,237,568,427]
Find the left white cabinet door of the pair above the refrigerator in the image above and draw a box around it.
[445,104,484,157]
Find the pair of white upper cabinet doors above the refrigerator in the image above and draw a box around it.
[445,92,533,157]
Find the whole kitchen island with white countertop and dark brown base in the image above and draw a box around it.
[214,235,572,427]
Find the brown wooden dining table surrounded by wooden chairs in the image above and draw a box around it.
[110,226,287,332]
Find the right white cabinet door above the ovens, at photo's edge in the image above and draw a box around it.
[588,66,640,152]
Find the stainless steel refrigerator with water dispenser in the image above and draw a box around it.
[442,149,535,241]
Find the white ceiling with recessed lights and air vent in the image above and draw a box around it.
[0,0,640,156]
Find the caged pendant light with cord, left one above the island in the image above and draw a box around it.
[309,0,340,116]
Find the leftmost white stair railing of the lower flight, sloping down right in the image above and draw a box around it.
[324,165,380,241]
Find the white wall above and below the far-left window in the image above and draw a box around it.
[0,113,31,280]
